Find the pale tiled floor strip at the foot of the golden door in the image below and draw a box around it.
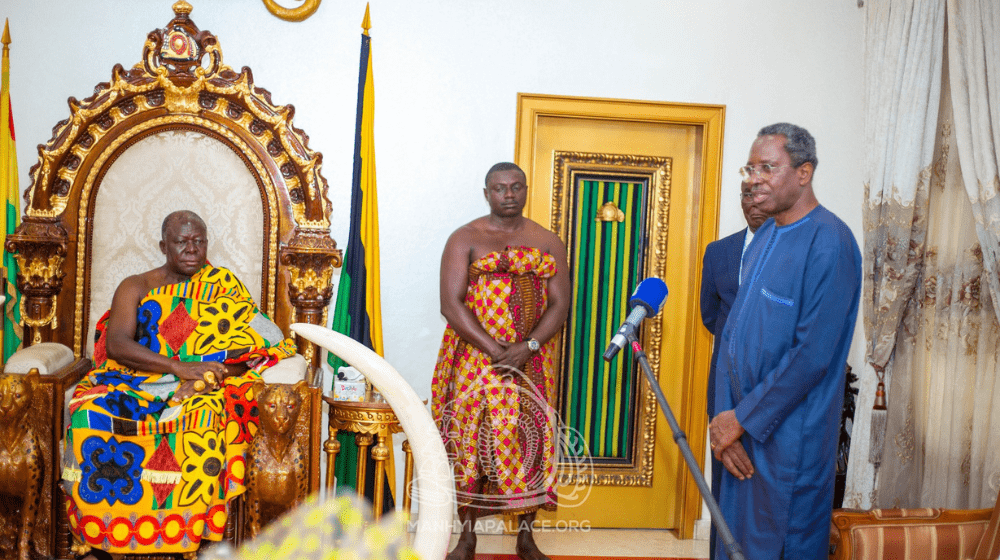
[448,529,708,558]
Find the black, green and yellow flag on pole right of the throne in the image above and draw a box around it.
[327,3,395,510]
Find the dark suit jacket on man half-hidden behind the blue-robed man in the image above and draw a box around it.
[701,228,747,419]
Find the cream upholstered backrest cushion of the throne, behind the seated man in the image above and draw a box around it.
[84,130,264,356]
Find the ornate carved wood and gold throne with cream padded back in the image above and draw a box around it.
[0,0,341,559]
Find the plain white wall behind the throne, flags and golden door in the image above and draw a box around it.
[0,0,863,506]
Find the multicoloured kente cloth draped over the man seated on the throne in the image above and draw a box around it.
[63,265,295,553]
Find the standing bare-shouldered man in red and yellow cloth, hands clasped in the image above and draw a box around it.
[431,163,570,560]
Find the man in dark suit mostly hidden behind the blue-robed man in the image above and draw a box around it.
[701,183,767,558]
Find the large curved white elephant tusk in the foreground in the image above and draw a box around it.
[291,323,455,560]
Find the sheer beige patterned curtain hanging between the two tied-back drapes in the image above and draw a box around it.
[877,82,1000,508]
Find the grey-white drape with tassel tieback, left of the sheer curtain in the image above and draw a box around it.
[844,0,945,508]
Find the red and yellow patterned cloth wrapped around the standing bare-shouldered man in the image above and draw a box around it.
[431,247,557,515]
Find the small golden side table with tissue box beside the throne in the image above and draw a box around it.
[323,395,413,519]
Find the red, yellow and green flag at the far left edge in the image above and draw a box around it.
[0,22,23,362]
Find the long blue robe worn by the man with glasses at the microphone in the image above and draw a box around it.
[715,206,861,560]
